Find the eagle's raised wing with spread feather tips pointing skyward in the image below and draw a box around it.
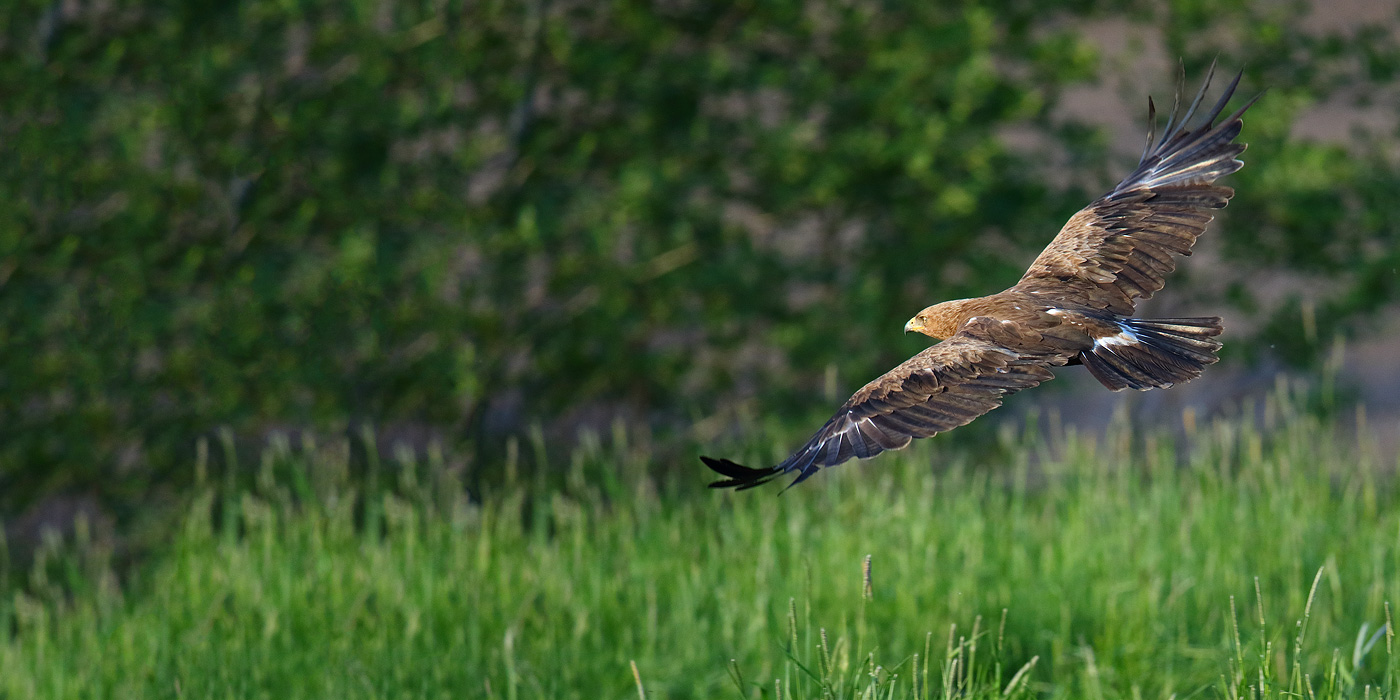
[1018,66,1259,315]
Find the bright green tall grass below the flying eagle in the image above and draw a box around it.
[0,386,1400,699]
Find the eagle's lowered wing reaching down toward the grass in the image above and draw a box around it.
[700,316,1075,490]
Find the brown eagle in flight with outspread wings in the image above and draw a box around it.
[700,66,1259,490]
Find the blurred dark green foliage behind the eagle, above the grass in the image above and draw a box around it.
[0,0,1400,514]
